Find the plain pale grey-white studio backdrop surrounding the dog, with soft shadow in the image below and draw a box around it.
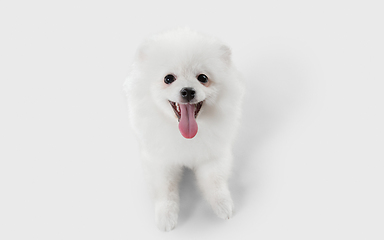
[0,0,384,240]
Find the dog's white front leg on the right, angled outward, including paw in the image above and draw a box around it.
[195,156,233,219]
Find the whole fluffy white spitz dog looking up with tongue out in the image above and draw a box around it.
[124,29,244,231]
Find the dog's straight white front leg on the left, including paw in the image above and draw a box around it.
[142,158,182,231]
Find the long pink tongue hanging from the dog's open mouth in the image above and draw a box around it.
[179,104,197,138]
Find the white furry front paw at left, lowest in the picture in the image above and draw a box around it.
[155,201,179,232]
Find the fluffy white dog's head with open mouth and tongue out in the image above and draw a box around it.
[134,30,231,138]
